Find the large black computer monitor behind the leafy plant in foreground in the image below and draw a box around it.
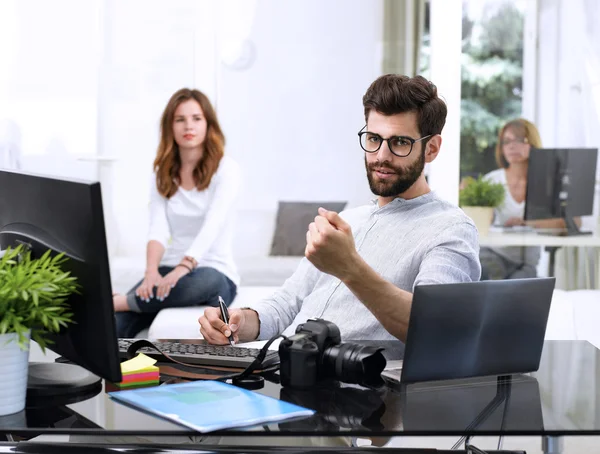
[0,170,122,393]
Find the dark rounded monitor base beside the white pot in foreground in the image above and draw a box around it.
[27,362,102,407]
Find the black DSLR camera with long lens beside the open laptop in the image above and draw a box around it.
[279,319,386,388]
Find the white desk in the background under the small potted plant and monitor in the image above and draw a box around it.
[479,231,600,282]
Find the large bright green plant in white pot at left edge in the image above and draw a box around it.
[0,245,80,416]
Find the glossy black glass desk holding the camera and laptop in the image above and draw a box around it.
[0,341,600,452]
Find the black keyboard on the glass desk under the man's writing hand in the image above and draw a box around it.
[119,339,279,369]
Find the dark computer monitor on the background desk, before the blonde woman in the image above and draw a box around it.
[524,148,598,235]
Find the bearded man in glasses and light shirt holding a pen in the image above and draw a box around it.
[199,74,481,344]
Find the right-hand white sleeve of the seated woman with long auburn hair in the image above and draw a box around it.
[185,158,242,261]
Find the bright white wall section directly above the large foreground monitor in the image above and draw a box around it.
[0,0,100,178]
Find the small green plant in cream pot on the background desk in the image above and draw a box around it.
[459,176,505,235]
